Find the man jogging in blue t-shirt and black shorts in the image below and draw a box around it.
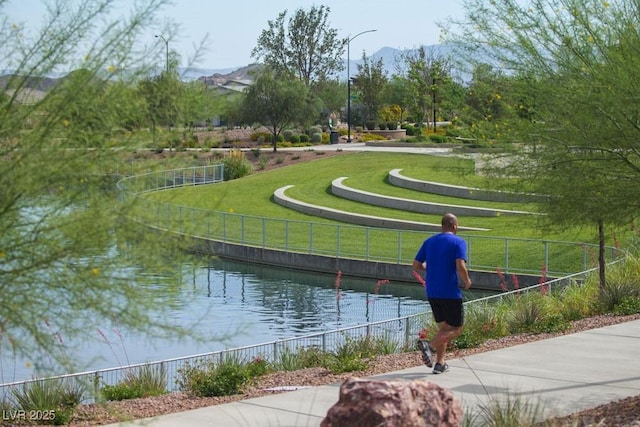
[413,213,471,374]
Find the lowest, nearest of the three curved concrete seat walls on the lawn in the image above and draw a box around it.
[273,185,488,232]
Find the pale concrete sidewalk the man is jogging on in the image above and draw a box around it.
[106,320,640,427]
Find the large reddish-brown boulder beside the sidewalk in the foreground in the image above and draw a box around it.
[320,378,462,427]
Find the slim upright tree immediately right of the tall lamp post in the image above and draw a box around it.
[353,52,388,124]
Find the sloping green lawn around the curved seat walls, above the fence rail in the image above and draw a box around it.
[148,152,595,242]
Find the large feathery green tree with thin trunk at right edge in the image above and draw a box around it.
[452,0,640,287]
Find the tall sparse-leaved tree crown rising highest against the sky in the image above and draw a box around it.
[251,6,347,86]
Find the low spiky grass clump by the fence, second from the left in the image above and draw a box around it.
[101,365,167,400]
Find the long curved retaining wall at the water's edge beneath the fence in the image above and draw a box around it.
[192,237,540,291]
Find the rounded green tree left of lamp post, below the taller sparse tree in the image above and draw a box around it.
[242,70,320,152]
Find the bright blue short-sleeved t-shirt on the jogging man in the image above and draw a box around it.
[415,233,467,299]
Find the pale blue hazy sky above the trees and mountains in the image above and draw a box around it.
[0,0,463,69]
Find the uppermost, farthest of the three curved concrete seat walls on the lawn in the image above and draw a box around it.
[389,169,547,203]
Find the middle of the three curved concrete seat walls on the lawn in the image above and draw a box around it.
[331,177,531,216]
